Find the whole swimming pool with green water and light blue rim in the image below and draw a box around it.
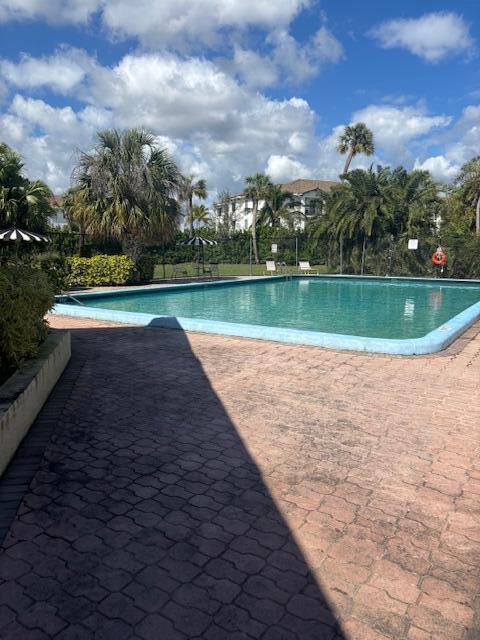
[55,276,480,354]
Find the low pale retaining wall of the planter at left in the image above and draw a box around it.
[0,331,70,476]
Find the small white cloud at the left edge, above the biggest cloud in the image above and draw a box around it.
[0,49,94,94]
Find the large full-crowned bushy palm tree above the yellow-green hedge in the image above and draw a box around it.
[74,129,183,261]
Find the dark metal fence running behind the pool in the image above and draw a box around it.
[42,231,480,278]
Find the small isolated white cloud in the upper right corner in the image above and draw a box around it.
[370,12,474,62]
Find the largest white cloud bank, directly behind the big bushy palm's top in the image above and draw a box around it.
[0,54,314,190]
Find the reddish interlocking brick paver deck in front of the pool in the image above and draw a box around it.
[0,317,480,640]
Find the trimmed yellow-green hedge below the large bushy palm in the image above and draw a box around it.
[67,255,135,287]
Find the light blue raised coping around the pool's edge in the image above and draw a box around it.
[52,274,480,356]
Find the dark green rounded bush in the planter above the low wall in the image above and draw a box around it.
[0,264,54,377]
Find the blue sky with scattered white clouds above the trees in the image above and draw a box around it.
[0,0,480,198]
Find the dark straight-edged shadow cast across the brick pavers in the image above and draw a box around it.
[0,327,345,640]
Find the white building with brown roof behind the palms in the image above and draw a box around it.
[215,179,340,231]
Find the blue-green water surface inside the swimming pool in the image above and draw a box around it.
[76,277,480,339]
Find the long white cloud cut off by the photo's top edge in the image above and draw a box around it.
[0,0,310,50]
